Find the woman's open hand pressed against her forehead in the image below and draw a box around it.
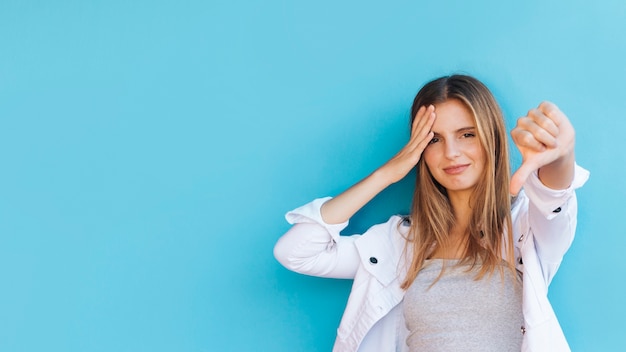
[378,105,436,184]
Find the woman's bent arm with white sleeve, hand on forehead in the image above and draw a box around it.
[274,106,435,278]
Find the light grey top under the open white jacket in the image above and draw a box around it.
[404,259,524,352]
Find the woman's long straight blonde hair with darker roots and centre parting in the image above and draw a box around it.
[401,75,514,289]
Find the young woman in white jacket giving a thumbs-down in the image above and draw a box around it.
[274,75,588,352]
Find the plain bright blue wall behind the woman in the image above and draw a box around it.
[0,0,626,351]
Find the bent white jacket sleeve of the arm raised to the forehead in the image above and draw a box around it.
[274,197,360,279]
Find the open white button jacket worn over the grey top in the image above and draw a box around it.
[274,166,589,352]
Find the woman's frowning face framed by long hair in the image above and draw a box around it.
[423,99,485,196]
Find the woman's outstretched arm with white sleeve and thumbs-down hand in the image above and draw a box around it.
[511,102,588,283]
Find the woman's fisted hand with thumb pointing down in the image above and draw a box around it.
[510,102,575,195]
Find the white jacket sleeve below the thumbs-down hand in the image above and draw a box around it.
[524,165,589,284]
